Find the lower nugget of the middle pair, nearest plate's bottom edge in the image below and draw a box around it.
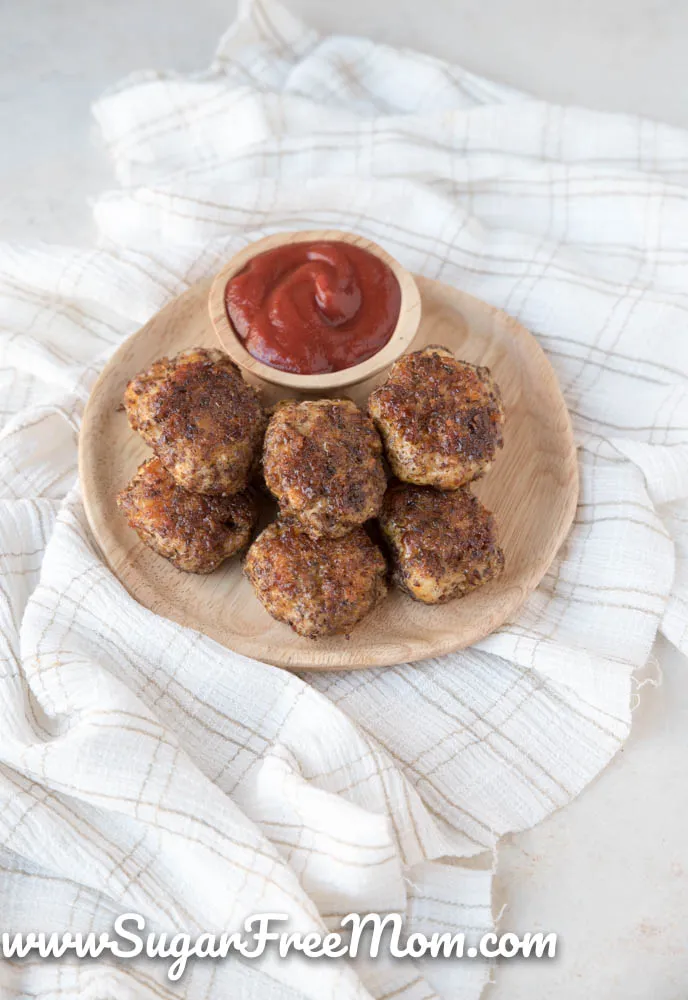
[244,519,387,639]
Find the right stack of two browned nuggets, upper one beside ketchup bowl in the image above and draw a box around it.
[368,346,504,604]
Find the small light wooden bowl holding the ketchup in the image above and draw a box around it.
[208,229,421,394]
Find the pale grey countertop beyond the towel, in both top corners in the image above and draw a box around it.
[0,0,688,243]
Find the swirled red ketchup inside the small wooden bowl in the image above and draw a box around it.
[225,241,401,375]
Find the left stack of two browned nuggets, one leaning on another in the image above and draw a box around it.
[117,348,266,573]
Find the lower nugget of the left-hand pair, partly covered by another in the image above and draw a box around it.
[117,458,258,573]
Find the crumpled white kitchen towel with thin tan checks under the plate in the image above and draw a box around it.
[0,0,688,1000]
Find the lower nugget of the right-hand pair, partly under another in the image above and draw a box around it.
[380,483,504,604]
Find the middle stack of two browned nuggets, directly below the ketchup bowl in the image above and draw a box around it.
[245,399,387,639]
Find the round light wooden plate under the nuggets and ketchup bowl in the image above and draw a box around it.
[79,278,578,670]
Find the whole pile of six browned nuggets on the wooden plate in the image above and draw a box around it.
[117,347,504,638]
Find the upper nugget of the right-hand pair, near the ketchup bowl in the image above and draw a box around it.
[368,347,504,490]
